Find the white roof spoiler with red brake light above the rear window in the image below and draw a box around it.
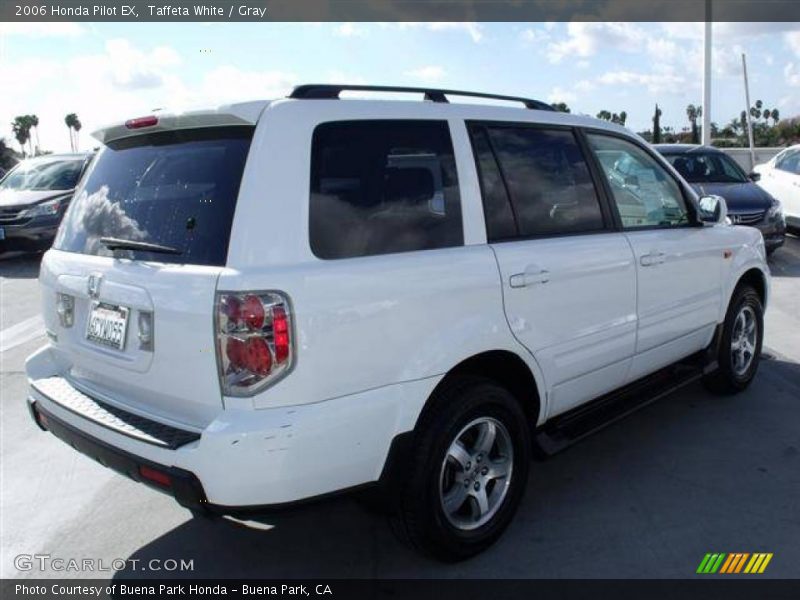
[92,101,270,144]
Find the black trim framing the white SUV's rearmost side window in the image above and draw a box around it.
[306,117,467,262]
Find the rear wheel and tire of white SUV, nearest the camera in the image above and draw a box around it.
[391,377,530,562]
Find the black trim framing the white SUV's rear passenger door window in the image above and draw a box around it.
[464,119,619,244]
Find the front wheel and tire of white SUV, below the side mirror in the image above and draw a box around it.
[704,285,764,394]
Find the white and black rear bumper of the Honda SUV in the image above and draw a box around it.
[27,347,439,512]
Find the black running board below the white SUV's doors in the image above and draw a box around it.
[535,353,717,455]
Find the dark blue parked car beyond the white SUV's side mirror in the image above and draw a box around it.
[655,144,786,254]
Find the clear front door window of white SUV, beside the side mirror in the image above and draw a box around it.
[587,134,690,229]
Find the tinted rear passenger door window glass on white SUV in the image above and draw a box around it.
[473,125,605,239]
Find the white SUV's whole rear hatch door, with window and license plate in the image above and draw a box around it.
[40,126,253,427]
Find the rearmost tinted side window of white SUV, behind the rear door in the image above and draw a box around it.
[310,120,464,259]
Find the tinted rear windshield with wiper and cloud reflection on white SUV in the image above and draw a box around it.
[54,127,253,266]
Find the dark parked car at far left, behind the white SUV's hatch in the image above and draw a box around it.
[0,154,91,252]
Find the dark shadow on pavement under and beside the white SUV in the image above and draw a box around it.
[115,358,800,579]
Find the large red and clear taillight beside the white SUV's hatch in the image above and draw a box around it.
[217,292,294,396]
